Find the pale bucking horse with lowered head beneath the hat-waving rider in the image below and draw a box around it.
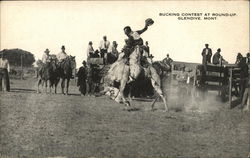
[106,46,168,111]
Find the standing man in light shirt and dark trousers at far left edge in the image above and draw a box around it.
[0,52,10,92]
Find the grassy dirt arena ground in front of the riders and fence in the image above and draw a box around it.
[0,78,250,158]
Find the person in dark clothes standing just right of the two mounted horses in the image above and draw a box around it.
[77,60,87,95]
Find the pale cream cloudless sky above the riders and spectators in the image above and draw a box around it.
[0,1,249,67]
